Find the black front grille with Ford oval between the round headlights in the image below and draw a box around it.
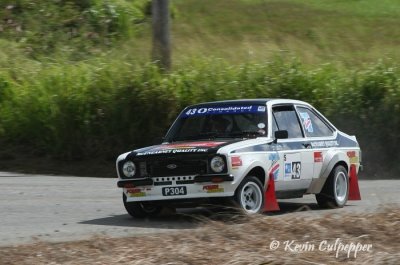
[147,158,207,177]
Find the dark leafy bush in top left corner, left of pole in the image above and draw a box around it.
[0,0,148,59]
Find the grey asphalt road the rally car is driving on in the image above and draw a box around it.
[0,172,400,246]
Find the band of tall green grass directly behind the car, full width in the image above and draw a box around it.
[0,58,400,177]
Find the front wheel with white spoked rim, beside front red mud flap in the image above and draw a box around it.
[234,176,265,214]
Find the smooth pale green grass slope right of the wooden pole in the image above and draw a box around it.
[168,0,400,67]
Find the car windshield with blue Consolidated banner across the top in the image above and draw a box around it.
[166,105,267,142]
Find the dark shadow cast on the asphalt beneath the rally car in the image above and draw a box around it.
[80,202,340,229]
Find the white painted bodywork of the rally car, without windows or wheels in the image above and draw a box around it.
[117,99,361,202]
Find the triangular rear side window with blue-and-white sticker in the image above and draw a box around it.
[297,107,333,137]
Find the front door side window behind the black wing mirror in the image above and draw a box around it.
[273,106,303,138]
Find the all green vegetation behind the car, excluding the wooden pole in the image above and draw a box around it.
[0,0,400,175]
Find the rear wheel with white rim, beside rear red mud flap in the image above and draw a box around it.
[315,165,349,209]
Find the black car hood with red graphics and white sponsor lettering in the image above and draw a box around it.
[130,139,241,157]
